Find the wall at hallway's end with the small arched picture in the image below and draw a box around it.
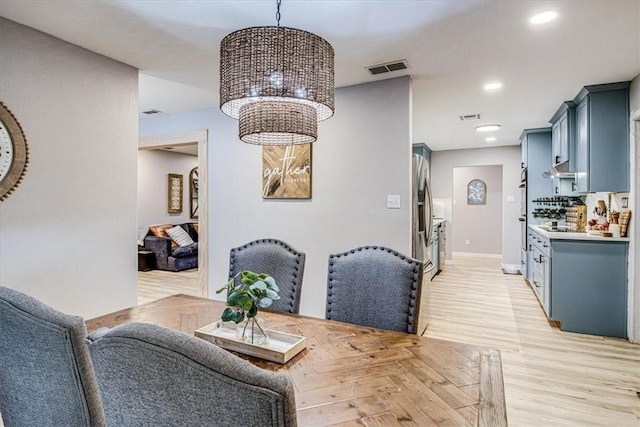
[451,166,503,255]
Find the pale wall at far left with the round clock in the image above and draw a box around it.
[0,18,138,317]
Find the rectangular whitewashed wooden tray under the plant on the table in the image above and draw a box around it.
[195,320,307,364]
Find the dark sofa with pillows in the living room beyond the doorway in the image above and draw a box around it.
[138,222,198,271]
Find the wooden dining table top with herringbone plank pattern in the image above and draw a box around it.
[87,295,507,427]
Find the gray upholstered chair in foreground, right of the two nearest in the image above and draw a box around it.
[89,323,296,426]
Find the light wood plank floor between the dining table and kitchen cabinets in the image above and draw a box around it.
[421,256,640,427]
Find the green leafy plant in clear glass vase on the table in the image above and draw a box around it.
[216,270,280,345]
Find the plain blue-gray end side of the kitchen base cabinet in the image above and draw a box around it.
[549,239,628,338]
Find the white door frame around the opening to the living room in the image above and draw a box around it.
[138,129,209,298]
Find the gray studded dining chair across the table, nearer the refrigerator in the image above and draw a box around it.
[326,246,424,334]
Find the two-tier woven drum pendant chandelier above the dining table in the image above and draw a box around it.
[220,0,335,145]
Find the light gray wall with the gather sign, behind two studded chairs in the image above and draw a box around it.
[140,77,411,317]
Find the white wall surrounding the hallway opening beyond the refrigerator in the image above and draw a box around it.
[431,145,522,265]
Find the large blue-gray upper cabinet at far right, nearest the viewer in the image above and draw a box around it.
[574,82,630,193]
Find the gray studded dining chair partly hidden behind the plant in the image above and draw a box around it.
[229,239,305,314]
